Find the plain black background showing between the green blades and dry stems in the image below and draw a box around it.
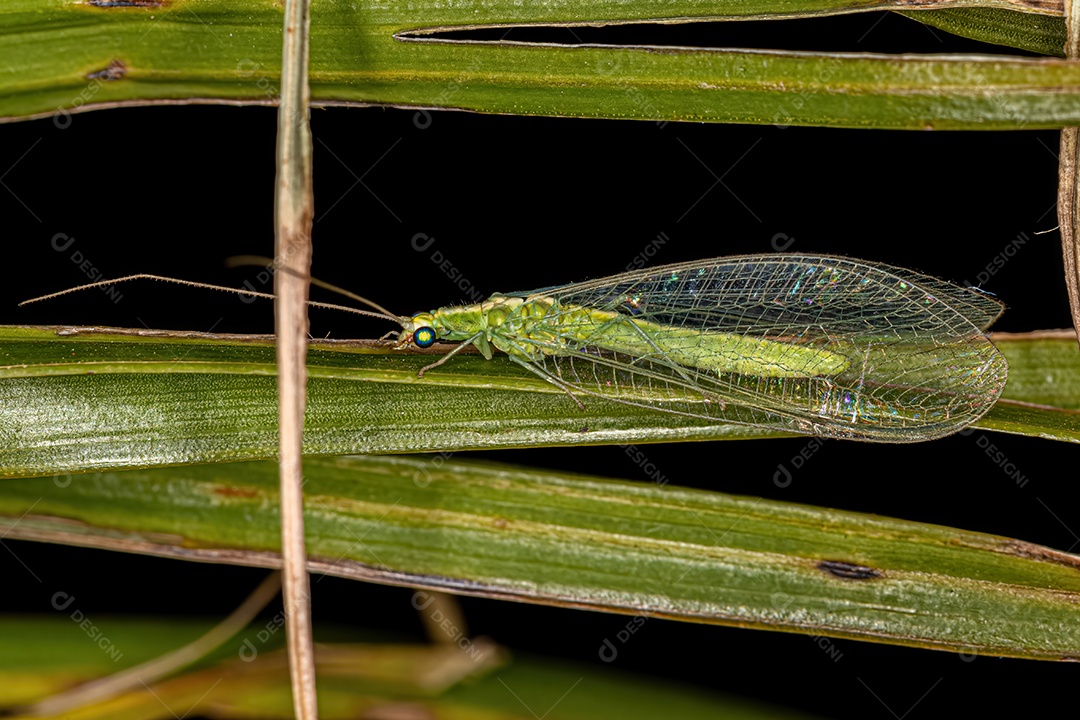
[0,13,1080,719]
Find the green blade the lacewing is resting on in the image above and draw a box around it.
[0,327,1080,477]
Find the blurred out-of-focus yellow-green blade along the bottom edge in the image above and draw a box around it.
[0,615,806,720]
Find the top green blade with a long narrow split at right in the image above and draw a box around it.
[0,0,1080,130]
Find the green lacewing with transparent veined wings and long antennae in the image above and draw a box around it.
[22,255,1009,443]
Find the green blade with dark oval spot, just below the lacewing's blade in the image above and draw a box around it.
[0,457,1080,660]
